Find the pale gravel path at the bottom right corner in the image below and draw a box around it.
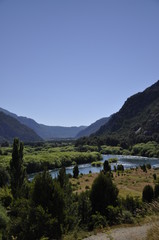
[84,223,152,240]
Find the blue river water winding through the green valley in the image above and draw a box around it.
[29,155,159,180]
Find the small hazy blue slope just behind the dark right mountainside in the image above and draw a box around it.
[76,117,110,138]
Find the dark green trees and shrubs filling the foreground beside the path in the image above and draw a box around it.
[0,139,159,240]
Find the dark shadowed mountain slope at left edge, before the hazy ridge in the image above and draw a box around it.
[0,112,42,142]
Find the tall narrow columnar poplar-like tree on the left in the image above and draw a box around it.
[10,138,25,198]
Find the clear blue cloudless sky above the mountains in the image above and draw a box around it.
[0,0,159,126]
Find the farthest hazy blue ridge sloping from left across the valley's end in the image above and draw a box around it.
[0,108,86,140]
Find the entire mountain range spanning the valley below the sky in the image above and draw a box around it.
[0,81,159,142]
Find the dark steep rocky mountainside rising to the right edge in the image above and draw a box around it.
[96,81,159,142]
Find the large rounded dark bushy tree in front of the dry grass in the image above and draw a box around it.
[90,173,118,215]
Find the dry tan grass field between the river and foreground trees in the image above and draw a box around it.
[70,168,159,197]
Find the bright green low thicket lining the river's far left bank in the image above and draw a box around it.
[0,143,101,173]
